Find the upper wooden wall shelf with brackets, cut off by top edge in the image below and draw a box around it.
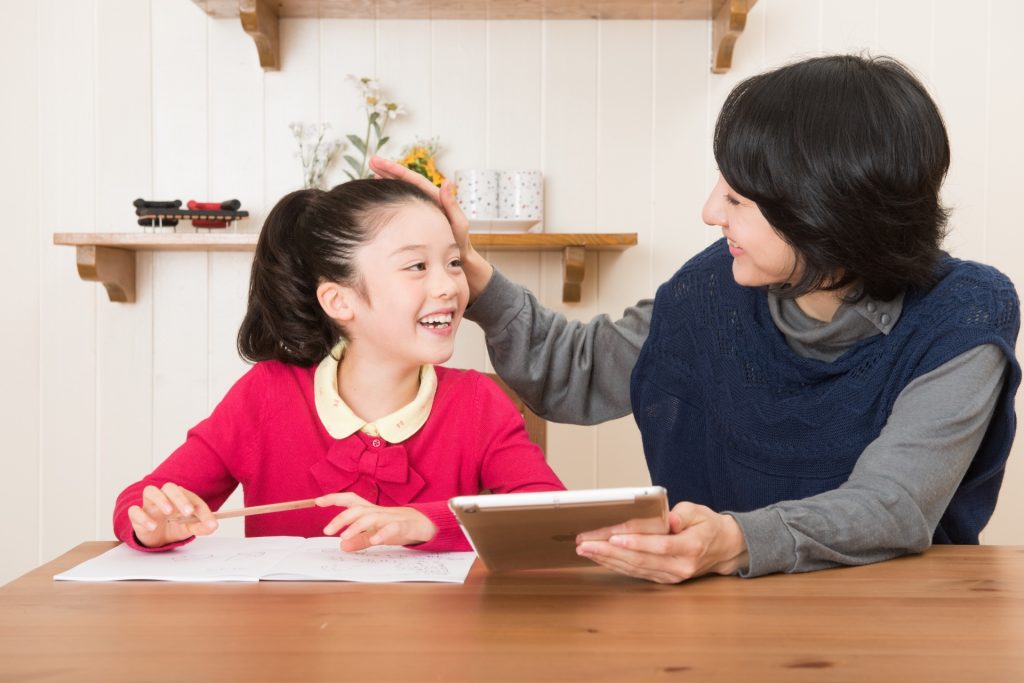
[193,0,757,74]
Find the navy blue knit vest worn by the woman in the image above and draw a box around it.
[631,240,1021,543]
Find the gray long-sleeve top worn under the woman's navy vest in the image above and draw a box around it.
[466,269,1008,577]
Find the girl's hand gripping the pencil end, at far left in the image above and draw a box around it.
[128,481,217,548]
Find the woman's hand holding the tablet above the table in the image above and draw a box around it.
[577,503,748,584]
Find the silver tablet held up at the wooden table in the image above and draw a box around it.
[449,486,669,571]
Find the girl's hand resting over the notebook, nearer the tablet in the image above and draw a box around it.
[316,494,437,552]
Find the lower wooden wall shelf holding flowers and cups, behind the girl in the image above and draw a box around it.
[53,232,637,303]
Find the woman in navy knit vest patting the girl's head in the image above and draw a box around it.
[377,55,1021,583]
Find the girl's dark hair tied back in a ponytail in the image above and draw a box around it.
[238,180,439,366]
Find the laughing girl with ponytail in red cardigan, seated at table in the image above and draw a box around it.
[114,180,563,550]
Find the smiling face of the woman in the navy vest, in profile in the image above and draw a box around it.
[701,175,800,287]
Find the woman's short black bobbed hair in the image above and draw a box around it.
[715,55,949,301]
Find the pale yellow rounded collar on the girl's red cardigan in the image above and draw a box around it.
[313,341,437,443]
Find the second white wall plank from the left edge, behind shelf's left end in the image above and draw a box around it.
[36,1,98,559]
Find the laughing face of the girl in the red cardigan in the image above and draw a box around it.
[344,202,469,368]
